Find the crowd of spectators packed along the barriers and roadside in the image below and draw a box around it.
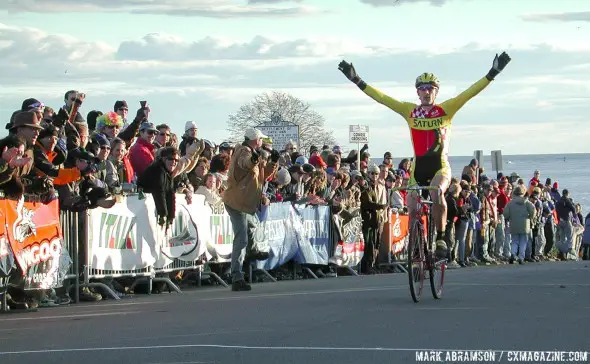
[0,90,590,307]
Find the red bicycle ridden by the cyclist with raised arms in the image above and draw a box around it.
[396,186,446,303]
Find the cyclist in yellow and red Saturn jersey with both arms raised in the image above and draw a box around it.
[338,52,510,258]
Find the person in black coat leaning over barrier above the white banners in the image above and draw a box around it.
[137,147,180,228]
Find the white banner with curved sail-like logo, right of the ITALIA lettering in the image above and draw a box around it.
[153,194,211,269]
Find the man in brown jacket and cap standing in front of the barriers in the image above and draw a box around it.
[223,128,280,291]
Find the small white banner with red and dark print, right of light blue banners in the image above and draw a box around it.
[330,216,365,267]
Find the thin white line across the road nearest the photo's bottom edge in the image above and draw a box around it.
[0,344,503,355]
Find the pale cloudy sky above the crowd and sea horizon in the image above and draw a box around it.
[0,0,590,156]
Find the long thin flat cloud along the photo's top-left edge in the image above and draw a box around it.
[0,0,323,18]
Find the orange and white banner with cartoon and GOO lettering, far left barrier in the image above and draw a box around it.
[0,198,72,289]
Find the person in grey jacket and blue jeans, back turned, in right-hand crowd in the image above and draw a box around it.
[504,186,535,264]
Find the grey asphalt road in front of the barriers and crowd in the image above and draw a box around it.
[0,262,590,364]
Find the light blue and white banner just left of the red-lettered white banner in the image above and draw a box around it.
[291,205,331,265]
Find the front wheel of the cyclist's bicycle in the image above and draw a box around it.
[408,220,424,303]
